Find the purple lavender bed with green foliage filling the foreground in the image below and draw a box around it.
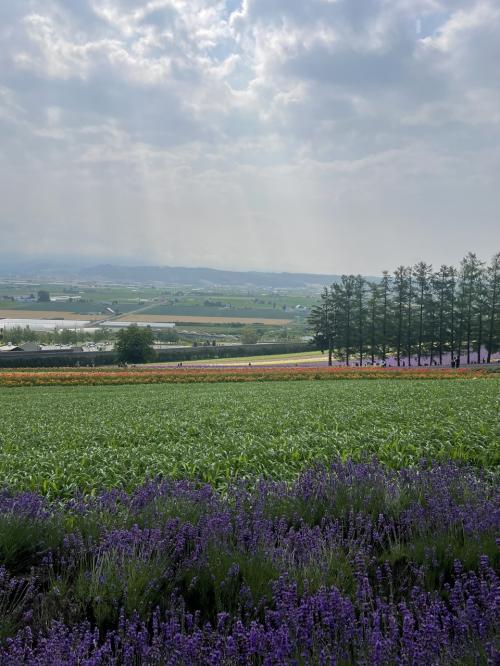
[0,463,500,666]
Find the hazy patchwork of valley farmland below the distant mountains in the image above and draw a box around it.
[0,282,310,337]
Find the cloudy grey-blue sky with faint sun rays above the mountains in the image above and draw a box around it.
[0,0,500,274]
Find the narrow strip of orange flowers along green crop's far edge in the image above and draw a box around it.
[0,366,494,387]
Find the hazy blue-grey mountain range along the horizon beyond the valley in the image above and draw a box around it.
[0,258,377,289]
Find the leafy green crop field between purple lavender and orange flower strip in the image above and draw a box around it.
[0,379,500,496]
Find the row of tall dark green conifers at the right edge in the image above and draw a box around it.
[309,252,500,366]
